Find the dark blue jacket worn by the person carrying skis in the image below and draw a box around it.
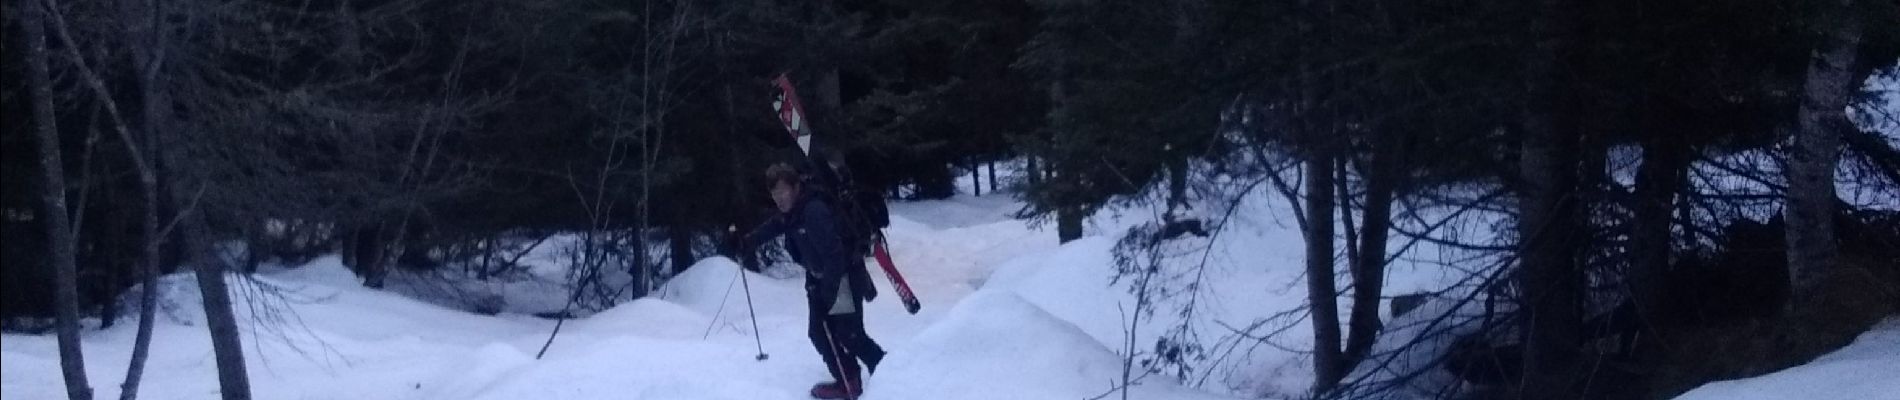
[745,191,851,307]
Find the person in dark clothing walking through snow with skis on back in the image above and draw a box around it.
[743,163,885,398]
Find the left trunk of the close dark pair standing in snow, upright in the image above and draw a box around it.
[1305,155,1345,392]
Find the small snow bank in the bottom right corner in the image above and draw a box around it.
[1676,317,1900,400]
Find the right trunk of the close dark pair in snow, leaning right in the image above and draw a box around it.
[1345,148,1398,364]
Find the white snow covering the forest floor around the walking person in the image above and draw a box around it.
[0,150,1527,400]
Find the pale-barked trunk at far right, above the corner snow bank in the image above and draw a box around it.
[1784,0,1860,305]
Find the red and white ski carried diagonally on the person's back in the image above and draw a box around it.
[771,74,923,315]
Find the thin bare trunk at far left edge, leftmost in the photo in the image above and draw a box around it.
[19,0,93,400]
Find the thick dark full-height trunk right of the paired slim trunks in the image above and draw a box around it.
[1518,0,1583,398]
